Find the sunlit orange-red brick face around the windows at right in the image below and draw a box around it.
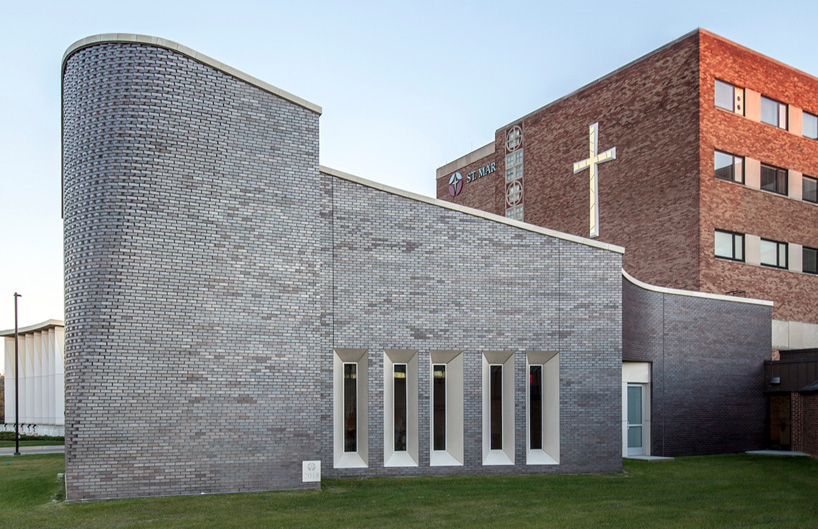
[699,34,818,323]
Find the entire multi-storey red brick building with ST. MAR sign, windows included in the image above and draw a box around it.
[437,29,818,349]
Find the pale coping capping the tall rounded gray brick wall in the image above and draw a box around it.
[62,33,322,115]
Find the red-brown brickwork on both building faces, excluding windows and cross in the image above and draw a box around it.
[438,30,818,326]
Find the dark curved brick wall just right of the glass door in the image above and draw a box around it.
[622,280,771,456]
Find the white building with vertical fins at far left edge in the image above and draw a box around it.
[0,320,65,435]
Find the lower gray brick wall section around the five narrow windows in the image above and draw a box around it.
[322,176,622,477]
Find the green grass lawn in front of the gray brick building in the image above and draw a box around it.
[0,454,818,529]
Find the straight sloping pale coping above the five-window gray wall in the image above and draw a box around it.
[318,165,625,254]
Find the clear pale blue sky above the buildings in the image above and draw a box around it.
[0,0,818,338]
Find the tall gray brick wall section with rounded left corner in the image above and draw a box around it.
[63,44,329,500]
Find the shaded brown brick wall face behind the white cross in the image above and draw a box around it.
[437,35,699,290]
